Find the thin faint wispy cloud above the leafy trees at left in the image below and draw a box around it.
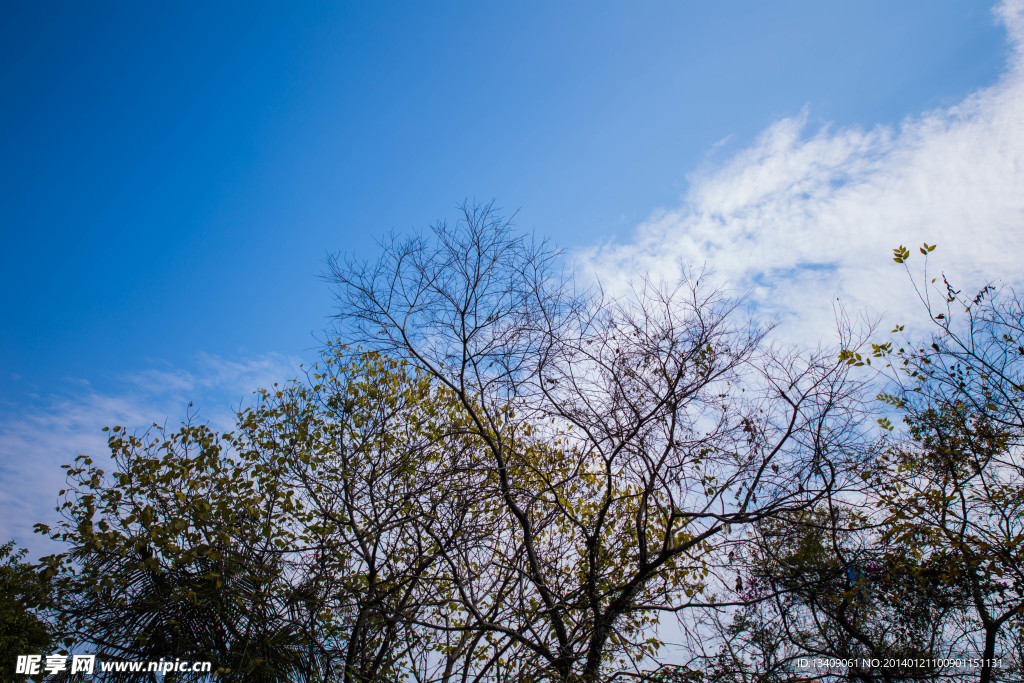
[0,354,300,551]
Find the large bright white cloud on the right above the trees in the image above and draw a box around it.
[579,0,1024,341]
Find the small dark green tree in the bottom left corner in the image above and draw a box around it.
[0,541,54,680]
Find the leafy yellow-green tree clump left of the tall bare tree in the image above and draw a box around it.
[36,346,475,683]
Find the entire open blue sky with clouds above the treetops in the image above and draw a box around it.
[0,0,1024,543]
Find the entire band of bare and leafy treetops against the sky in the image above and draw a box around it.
[19,206,1024,683]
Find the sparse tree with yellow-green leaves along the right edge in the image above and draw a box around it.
[876,244,1024,683]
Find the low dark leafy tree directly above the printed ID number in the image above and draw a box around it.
[709,499,965,683]
